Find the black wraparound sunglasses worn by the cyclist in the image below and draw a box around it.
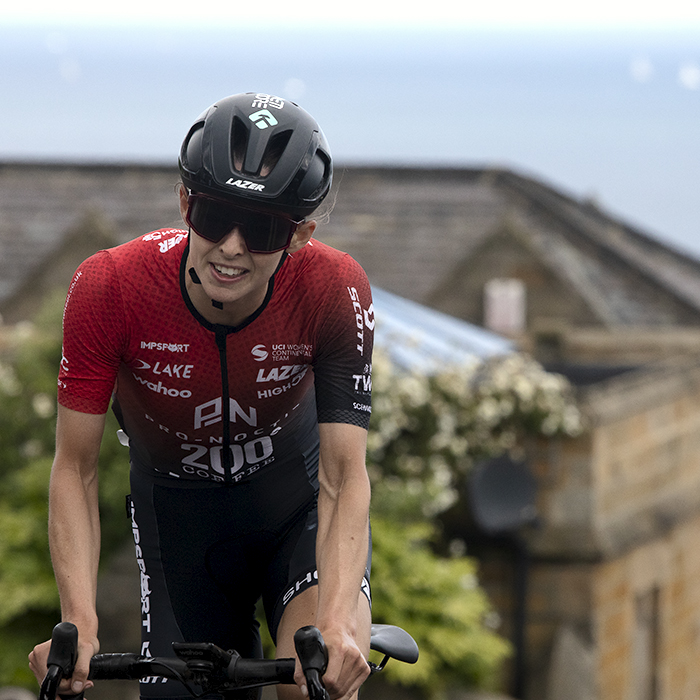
[185,192,304,253]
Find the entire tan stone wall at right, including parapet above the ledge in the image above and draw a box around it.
[504,360,700,700]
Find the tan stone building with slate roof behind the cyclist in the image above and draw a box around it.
[0,163,700,700]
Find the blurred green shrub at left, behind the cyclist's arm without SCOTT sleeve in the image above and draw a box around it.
[0,298,130,687]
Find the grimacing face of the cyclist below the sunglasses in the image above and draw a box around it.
[180,187,316,325]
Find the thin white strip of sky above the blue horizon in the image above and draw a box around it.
[2,0,700,29]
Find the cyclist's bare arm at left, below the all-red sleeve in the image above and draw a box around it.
[30,406,105,692]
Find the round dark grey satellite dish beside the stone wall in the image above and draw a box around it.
[469,455,537,535]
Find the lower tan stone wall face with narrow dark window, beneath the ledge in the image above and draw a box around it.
[592,516,700,700]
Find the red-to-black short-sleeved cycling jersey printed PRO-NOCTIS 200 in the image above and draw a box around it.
[58,229,374,484]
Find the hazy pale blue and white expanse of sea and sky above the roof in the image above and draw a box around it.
[0,0,700,256]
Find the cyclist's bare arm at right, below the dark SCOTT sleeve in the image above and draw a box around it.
[316,423,370,697]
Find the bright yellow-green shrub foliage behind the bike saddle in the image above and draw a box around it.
[372,517,510,697]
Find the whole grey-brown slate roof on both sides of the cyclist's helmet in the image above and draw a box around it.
[0,163,700,327]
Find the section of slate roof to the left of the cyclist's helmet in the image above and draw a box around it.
[0,163,179,317]
